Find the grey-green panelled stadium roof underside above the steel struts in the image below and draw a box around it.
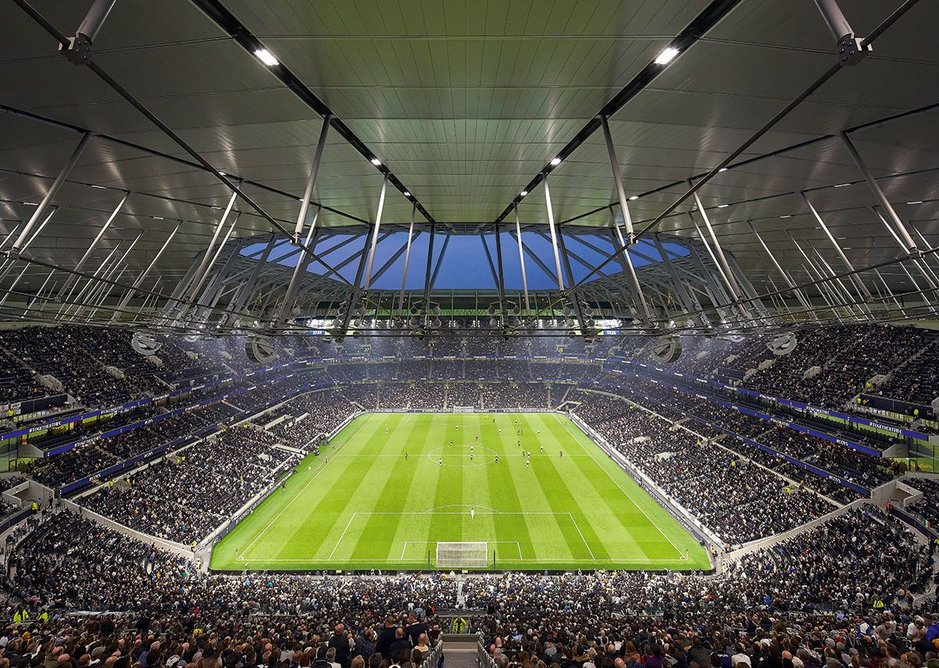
[0,0,939,334]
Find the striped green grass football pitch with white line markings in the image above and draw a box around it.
[211,413,709,571]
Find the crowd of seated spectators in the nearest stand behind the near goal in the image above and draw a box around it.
[3,506,936,668]
